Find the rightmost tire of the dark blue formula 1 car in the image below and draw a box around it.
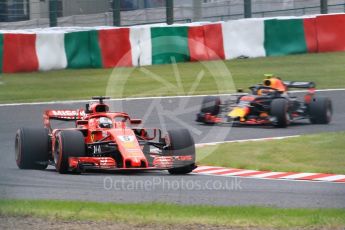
[309,97,333,124]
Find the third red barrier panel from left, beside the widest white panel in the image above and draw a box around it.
[188,24,225,61]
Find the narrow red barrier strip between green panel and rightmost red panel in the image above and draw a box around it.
[303,18,317,53]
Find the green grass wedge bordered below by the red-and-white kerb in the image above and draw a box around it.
[197,132,345,174]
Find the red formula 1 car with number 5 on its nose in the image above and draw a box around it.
[15,97,196,174]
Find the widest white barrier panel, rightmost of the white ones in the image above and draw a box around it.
[222,19,266,59]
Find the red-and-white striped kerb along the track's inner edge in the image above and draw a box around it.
[193,166,345,183]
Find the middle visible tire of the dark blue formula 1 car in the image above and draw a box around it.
[271,98,290,128]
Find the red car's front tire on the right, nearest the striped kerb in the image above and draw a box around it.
[167,129,196,174]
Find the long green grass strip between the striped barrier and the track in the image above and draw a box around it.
[0,52,345,103]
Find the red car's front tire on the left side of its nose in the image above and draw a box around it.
[54,130,86,174]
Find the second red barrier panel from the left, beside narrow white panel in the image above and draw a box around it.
[99,28,132,68]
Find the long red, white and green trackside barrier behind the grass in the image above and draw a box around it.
[0,14,345,73]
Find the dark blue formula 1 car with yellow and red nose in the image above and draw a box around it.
[196,75,332,127]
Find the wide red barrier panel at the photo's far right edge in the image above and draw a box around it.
[316,14,345,52]
